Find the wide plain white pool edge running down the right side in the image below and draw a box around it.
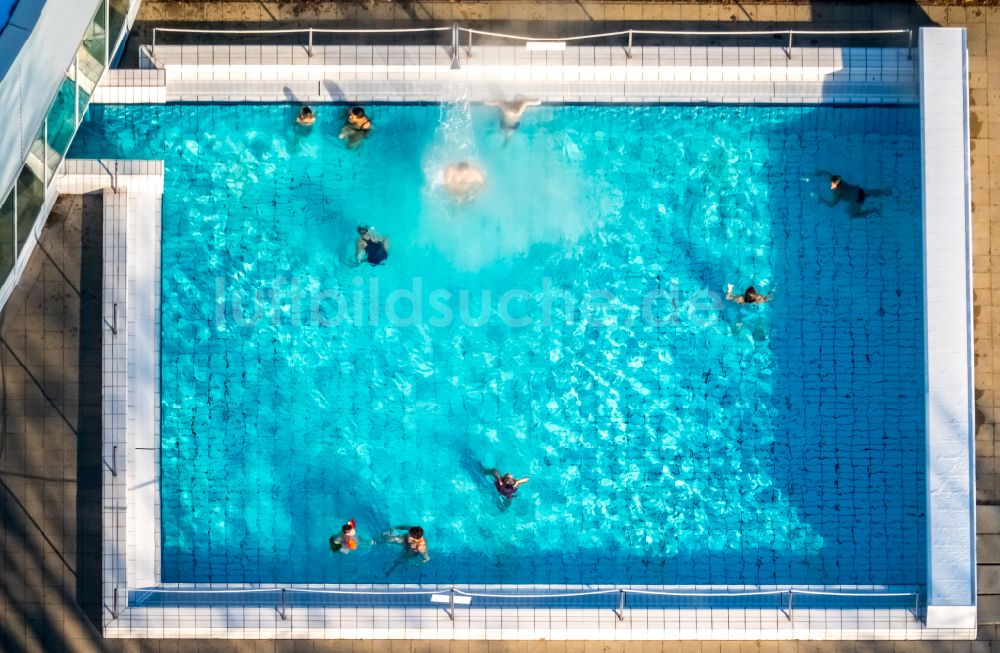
[920,28,976,628]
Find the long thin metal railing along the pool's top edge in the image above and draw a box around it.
[150,23,914,68]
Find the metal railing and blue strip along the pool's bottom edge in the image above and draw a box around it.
[123,587,921,621]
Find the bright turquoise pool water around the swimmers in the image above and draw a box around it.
[70,104,925,585]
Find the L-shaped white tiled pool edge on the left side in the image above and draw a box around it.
[54,160,163,636]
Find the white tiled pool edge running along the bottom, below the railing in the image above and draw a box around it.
[99,607,952,640]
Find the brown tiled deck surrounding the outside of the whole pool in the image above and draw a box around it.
[0,0,1000,653]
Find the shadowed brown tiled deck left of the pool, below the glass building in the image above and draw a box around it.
[0,195,102,653]
